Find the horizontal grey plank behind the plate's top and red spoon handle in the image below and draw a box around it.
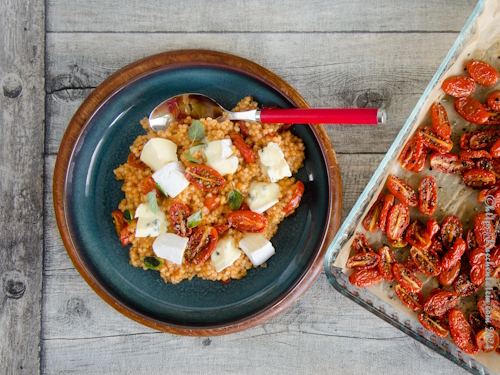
[46,33,456,153]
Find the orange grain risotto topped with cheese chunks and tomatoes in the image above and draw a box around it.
[112,97,305,284]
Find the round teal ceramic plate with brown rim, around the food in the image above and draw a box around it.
[54,51,341,335]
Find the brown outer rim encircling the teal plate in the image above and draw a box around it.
[53,50,342,336]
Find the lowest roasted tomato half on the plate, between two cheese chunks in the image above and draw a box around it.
[184,226,219,266]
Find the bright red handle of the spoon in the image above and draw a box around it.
[260,108,385,125]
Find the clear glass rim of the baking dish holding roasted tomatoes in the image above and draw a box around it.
[325,0,498,374]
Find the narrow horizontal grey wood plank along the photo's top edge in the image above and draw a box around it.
[47,0,477,33]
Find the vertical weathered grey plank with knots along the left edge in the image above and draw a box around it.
[0,0,45,374]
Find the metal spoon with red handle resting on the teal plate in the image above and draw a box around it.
[149,93,386,132]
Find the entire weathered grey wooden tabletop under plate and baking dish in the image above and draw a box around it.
[0,0,484,375]
